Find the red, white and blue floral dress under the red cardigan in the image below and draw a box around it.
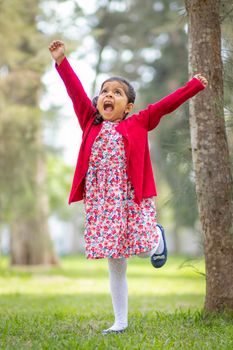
[84,121,158,259]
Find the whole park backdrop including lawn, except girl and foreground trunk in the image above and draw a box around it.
[0,0,233,350]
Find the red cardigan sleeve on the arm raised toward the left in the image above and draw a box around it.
[55,57,96,130]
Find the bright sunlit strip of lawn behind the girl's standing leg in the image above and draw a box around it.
[0,256,205,306]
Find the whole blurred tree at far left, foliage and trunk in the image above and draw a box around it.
[0,0,57,265]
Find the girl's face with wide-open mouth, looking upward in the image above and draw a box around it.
[97,81,133,123]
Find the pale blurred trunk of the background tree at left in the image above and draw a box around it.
[10,126,58,265]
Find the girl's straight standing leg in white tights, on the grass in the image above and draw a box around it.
[103,258,128,333]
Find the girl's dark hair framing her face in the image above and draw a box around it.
[92,77,136,125]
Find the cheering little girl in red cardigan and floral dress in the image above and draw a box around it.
[49,40,207,334]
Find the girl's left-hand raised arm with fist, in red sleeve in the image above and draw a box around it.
[49,40,96,130]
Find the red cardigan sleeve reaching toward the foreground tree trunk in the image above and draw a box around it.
[136,78,205,131]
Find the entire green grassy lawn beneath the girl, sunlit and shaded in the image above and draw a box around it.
[0,257,233,350]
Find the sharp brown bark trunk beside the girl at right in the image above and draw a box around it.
[185,0,233,311]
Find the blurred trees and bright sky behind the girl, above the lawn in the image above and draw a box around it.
[0,0,233,264]
